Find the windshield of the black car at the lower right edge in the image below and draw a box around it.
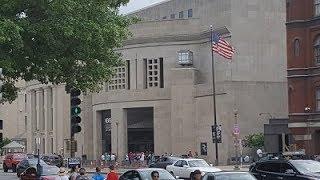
[290,160,320,174]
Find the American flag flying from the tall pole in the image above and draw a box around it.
[212,34,235,59]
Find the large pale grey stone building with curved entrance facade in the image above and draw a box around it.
[0,0,288,164]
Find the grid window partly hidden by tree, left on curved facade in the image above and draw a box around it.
[108,66,127,91]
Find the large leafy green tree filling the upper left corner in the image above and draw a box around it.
[0,0,136,101]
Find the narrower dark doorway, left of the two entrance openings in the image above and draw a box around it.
[101,110,111,153]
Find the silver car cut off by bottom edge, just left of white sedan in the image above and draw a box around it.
[119,168,175,180]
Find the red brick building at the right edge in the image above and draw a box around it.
[287,0,320,155]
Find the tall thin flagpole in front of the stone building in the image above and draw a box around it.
[210,25,219,166]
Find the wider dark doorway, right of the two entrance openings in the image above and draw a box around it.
[127,107,154,152]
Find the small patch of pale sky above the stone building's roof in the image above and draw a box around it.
[120,0,165,14]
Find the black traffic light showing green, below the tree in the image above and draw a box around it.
[70,89,81,136]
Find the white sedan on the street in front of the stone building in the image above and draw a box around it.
[166,159,221,178]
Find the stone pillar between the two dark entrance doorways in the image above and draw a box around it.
[111,108,128,161]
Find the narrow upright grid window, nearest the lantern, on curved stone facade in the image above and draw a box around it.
[147,59,160,88]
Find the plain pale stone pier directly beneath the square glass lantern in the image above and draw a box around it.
[171,68,197,154]
